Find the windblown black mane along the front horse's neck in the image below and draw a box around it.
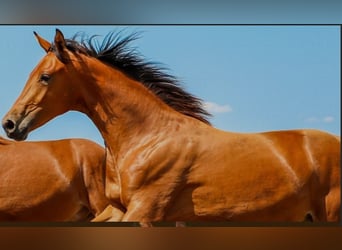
[53,32,211,125]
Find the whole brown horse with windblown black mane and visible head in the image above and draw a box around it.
[3,30,340,222]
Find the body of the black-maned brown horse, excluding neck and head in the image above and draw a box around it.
[109,116,340,221]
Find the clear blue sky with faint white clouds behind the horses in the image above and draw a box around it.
[0,25,341,144]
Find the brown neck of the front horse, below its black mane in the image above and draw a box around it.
[80,58,180,152]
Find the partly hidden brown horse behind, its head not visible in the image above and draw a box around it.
[0,137,123,222]
